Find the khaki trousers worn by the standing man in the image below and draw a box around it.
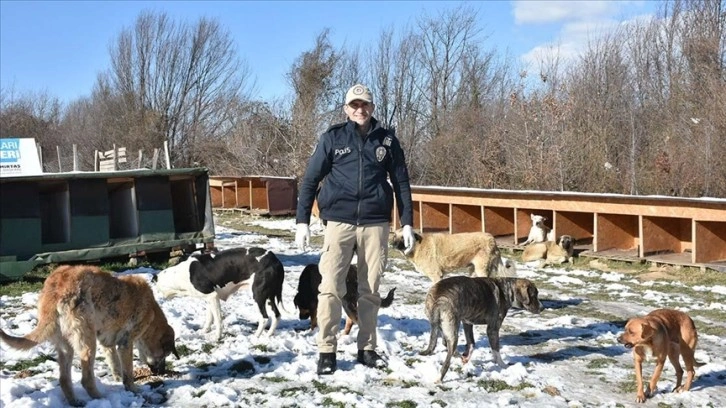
[317,221,390,353]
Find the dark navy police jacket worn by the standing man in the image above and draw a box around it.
[297,118,413,226]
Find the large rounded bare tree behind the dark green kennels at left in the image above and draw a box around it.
[109,12,249,165]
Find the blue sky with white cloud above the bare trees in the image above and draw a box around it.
[0,0,657,102]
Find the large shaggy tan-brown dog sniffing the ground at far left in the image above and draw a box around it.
[0,265,179,406]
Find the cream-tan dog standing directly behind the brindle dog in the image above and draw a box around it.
[391,229,516,283]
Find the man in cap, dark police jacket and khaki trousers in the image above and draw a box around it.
[295,84,415,374]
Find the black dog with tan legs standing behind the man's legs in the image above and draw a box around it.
[294,264,396,334]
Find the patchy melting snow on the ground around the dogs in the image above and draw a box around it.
[0,218,726,408]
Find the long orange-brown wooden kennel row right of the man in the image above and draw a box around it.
[394,186,726,271]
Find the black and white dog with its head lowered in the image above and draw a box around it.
[154,248,285,341]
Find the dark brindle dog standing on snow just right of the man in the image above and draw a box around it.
[419,276,543,382]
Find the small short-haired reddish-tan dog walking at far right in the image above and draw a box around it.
[618,309,703,402]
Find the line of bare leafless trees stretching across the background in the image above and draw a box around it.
[0,0,726,197]
